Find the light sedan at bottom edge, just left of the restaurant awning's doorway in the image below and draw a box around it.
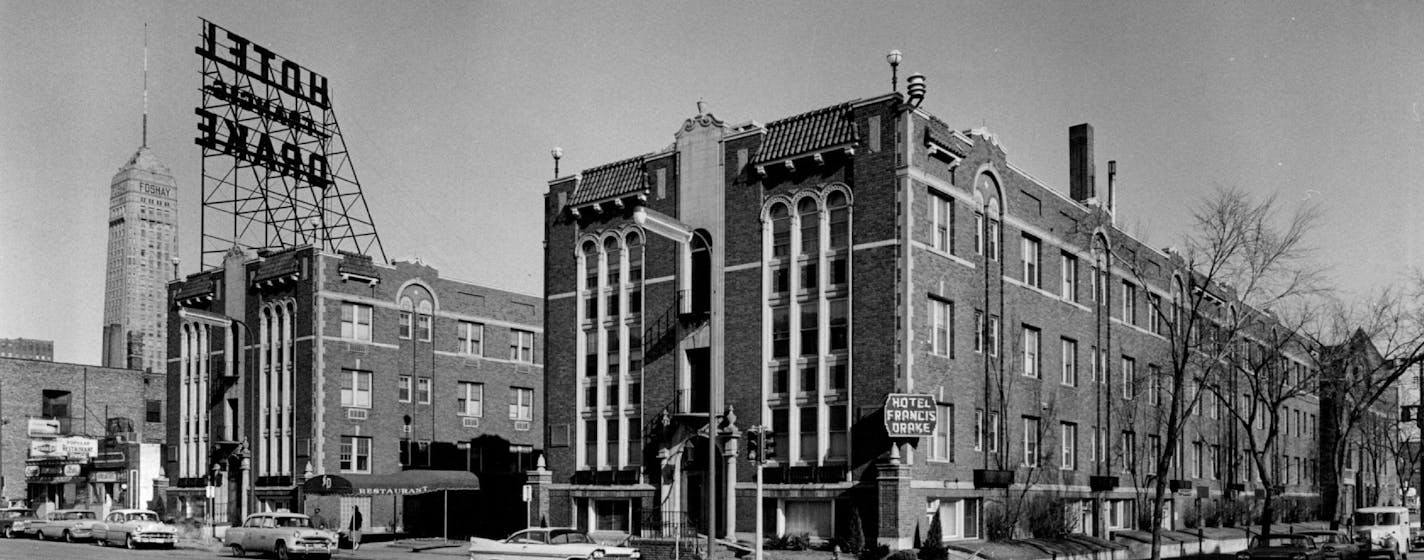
[222,512,337,560]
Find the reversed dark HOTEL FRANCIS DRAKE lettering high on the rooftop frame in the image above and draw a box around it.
[194,20,332,187]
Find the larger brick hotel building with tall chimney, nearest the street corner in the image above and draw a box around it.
[535,94,1338,547]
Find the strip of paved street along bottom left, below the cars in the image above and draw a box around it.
[0,539,461,560]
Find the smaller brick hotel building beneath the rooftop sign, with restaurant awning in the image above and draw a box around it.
[164,247,544,536]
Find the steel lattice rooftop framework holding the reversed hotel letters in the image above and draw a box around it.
[194,20,386,268]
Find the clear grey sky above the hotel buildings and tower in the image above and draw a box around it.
[0,0,1424,363]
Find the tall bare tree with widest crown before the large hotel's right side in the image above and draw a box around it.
[1089,183,1320,560]
